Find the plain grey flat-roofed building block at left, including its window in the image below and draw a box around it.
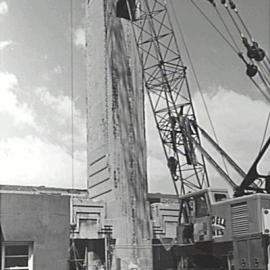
[0,189,70,270]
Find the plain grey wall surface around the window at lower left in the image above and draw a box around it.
[0,193,70,270]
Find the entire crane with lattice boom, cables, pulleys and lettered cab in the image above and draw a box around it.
[117,0,270,270]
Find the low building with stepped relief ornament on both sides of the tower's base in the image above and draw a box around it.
[0,185,178,270]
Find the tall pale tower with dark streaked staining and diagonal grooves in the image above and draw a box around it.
[86,0,152,270]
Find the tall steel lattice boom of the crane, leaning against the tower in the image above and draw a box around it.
[126,0,209,195]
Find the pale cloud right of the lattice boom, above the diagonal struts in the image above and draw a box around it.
[194,87,270,169]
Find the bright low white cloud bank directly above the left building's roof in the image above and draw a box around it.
[0,136,86,188]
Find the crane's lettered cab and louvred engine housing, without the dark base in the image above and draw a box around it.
[177,188,270,244]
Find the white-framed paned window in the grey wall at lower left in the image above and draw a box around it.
[1,242,33,270]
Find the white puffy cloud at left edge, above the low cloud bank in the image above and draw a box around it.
[0,72,36,127]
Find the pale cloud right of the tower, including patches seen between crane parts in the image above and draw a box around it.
[146,86,270,193]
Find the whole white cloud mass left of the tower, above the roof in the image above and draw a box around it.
[0,72,86,187]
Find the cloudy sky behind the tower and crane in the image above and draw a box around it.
[0,0,270,192]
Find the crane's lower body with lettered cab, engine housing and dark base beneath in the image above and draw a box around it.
[176,188,270,270]
